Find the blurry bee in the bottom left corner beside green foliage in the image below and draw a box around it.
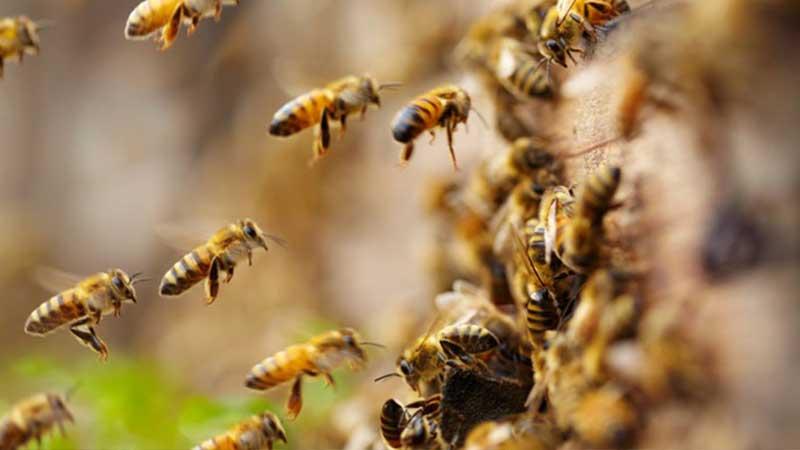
[0,393,75,450]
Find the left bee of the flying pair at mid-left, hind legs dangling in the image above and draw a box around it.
[25,269,146,361]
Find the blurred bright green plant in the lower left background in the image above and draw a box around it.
[0,352,353,450]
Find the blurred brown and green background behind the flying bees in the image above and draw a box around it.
[0,0,495,449]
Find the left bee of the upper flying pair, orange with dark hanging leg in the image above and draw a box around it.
[269,75,399,162]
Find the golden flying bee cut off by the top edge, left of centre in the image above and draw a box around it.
[125,0,239,50]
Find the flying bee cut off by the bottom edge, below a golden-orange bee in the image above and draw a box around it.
[192,411,286,450]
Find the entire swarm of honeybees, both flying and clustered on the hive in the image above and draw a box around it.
[0,0,792,450]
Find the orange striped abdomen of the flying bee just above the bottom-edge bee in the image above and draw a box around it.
[245,344,316,390]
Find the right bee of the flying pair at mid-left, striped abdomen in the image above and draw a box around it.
[159,219,284,305]
